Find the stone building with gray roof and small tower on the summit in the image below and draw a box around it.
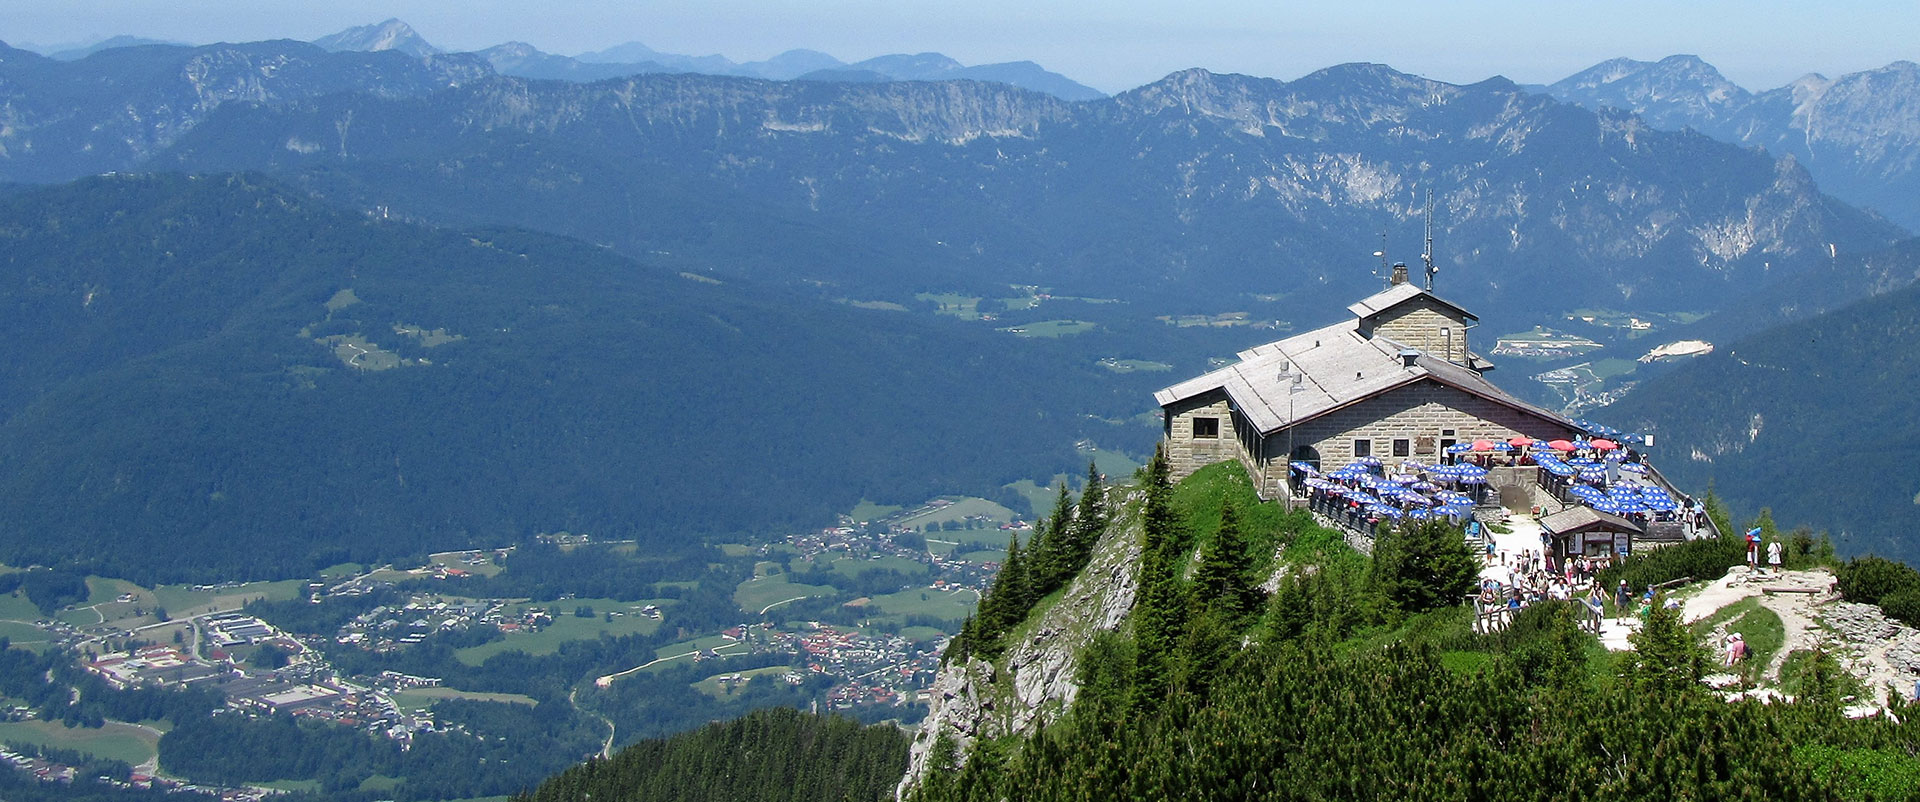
[1154,271,1578,501]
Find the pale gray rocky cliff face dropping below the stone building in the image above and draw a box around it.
[900,493,1140,796]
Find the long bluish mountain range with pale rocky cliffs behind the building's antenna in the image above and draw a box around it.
[0,36,1905,322]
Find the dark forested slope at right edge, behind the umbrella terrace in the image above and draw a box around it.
[1596,244,1920,560]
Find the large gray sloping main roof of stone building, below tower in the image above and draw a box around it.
[1154,316,1572,436]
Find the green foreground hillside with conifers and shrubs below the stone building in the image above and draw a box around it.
[906,454,1920,802]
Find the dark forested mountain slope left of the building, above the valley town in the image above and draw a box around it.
[0,177,1152,581]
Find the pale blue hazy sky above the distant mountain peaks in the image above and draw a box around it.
[0,0,1920,92]
